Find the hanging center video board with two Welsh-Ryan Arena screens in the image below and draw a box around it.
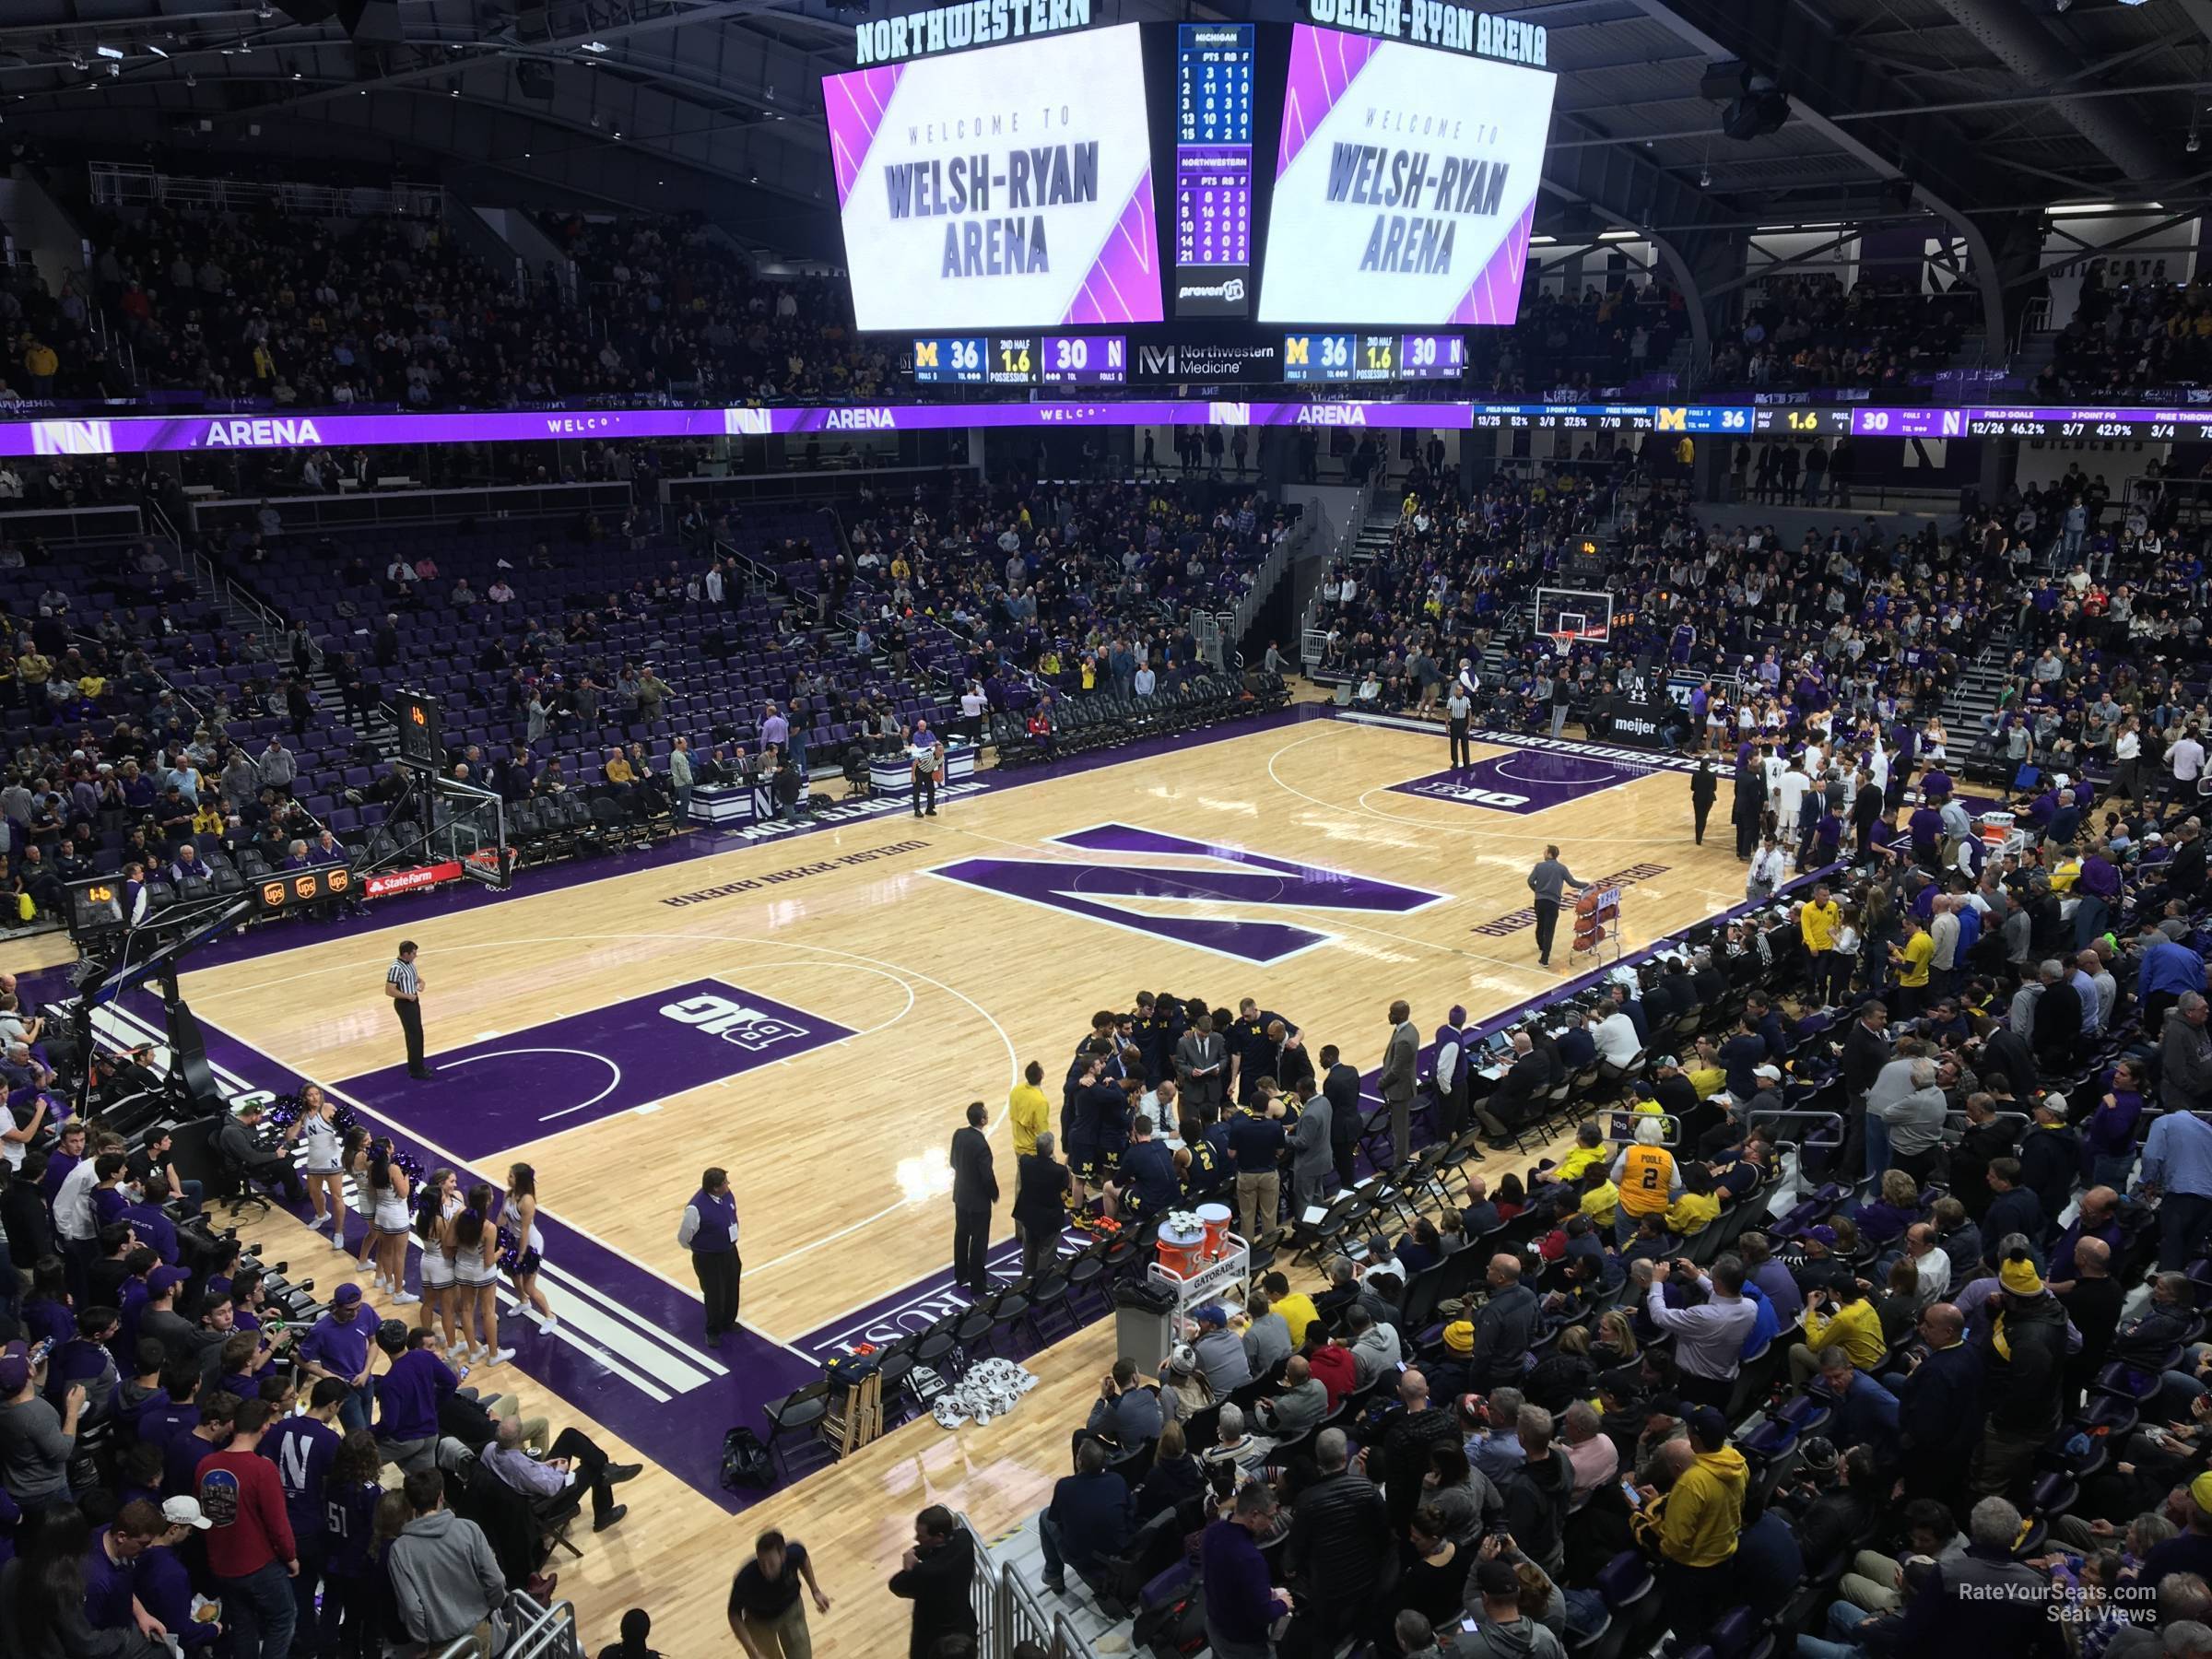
[823,0,1555,358]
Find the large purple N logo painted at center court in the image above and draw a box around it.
[929,823,1449,964]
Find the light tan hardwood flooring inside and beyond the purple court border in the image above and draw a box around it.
[186,719,1743,1659]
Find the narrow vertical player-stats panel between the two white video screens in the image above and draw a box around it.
[1174,22,1254,316]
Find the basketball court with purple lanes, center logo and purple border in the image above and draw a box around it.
[55,706,1743,1653]
